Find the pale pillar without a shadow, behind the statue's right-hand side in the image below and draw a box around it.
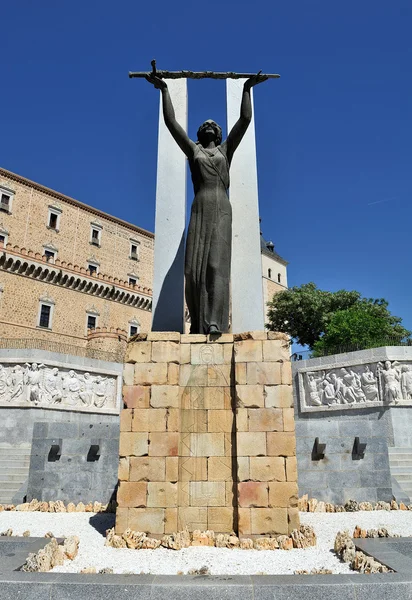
[226,79,264,333]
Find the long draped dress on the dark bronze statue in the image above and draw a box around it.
[185,144,232,333]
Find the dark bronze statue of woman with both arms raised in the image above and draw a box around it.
[146,74,267,334]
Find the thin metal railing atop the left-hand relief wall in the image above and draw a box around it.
[0,338,124,363]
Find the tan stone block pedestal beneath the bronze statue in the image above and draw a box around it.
[116,331,299,537]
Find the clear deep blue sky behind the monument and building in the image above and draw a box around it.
[0,0,412,329]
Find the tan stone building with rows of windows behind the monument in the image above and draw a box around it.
[0,168,287,347]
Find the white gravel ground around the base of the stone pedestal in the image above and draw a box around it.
[0,511,412,575]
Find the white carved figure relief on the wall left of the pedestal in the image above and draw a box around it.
[0,362,117,412]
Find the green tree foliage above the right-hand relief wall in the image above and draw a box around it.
[267,283,411,355]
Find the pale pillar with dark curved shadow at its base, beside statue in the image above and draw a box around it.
[152,79,187,333]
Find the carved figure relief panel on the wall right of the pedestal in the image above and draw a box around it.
[299,360,412,412]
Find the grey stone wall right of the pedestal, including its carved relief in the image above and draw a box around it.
[293,346,412,504]
